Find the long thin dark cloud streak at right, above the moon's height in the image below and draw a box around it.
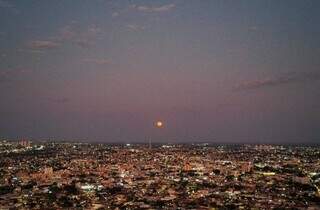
[233,72,320,90]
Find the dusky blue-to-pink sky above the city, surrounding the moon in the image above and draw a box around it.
[0,0,320,143]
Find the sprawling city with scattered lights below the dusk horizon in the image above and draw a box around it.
[0,140,320,209]
